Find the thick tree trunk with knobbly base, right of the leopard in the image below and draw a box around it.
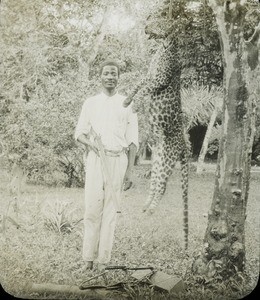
[193,0,259,279]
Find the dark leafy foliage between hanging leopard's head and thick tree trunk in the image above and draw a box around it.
[143,0,223,87]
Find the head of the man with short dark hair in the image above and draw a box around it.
[100,60,119,92]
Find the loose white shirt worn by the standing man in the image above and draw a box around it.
[75,92,138,151]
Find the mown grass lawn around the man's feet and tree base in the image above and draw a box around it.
[0,166,260,300]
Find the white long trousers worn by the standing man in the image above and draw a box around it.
[82,151,128,264]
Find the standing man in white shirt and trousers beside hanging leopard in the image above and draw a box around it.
[75,61,138,270]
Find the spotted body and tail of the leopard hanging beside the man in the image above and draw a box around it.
[124,35,189,249]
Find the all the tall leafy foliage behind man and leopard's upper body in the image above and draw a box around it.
[0,0,257,186]
